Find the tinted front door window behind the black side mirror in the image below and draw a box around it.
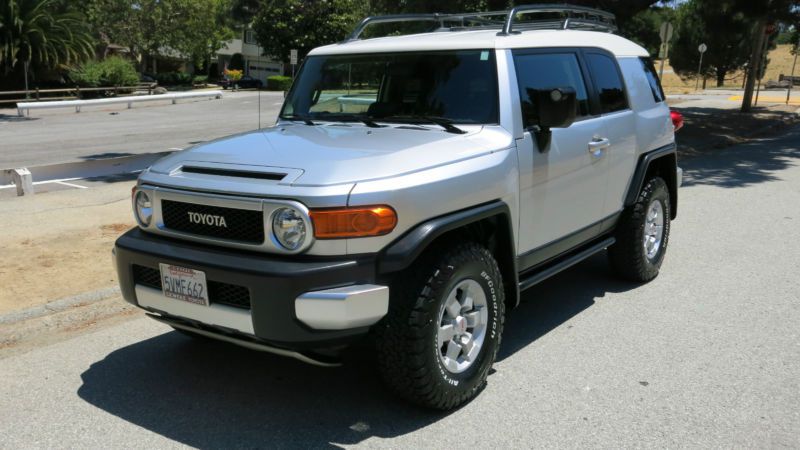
[514,52,589,127]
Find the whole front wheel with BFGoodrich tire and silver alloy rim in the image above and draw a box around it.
[377,243,505,410]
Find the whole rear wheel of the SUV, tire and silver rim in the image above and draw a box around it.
[608,177,672,282]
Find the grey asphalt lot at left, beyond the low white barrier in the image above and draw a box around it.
[0,91,283,169]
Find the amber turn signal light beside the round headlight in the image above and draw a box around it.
[310,205,397,239]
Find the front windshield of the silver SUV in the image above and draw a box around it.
[281,50,498,124]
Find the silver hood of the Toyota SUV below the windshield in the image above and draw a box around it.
[151,123,513,186]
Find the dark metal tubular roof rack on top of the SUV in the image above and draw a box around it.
[344,4,617,42]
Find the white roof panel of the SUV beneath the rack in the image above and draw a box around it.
[309,30,649,57]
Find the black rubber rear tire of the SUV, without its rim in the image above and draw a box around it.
[608,177,672,282]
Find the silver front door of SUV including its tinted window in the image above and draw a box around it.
[513,49,608,254]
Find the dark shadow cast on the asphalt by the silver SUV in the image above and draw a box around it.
[78,255,635,448]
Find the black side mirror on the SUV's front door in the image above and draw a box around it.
[522,87,578,152]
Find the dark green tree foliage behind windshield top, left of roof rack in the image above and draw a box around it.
[253,0,367,61]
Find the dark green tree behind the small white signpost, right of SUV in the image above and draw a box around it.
[670,0,751,87]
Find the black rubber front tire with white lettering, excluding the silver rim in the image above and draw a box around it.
[377,242,505,410]
